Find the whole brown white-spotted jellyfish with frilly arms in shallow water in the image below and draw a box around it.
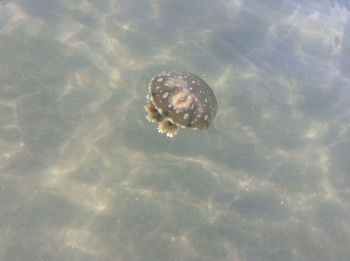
[146,71,217,137]
